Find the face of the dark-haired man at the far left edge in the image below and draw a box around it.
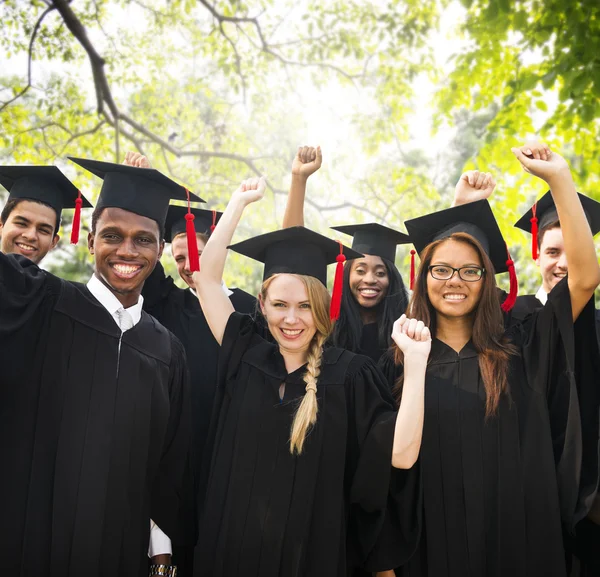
[0,200,60,264]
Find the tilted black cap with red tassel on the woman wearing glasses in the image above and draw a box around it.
[404,200,518,312]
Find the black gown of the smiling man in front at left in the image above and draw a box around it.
[0,253,190,577]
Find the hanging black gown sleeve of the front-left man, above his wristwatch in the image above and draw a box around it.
[150,335,197,546]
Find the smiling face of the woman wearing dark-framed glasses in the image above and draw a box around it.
[427,240,484,317]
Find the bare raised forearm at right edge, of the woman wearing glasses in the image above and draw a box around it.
[548,168,600,291]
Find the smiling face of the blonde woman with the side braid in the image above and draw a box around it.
[260,274,317,353]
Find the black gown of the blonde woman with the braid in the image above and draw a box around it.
[194,313,419,577]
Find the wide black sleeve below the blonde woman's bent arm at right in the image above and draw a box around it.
[348,356,421,571]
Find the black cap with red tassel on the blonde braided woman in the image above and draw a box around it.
[229,226,363,320]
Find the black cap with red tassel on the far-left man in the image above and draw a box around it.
[0,166,92,244]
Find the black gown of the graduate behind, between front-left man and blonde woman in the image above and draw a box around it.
[142,262,256,475]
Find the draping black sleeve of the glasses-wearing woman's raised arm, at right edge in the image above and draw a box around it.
[519,278,600,530]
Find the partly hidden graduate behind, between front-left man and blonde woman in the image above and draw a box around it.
[142,205,256,577]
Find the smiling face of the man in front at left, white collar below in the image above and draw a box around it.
[88,207,164,308]
